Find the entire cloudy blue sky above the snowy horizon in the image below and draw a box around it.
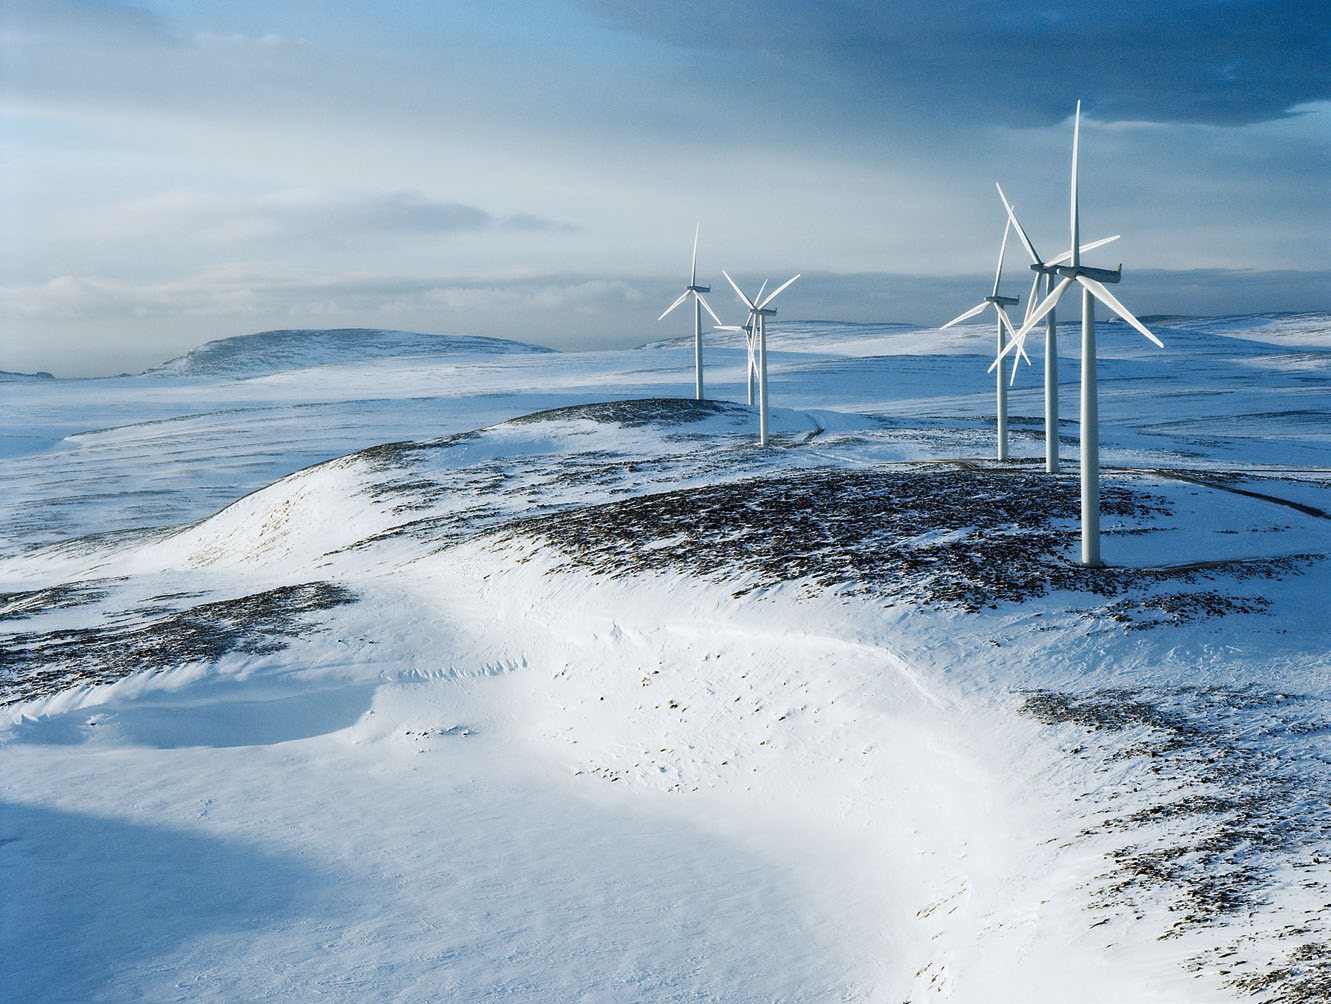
[0,0,1331,376]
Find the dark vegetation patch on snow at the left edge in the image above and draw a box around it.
[0,582,355,706]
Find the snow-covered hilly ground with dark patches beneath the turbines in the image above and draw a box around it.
[0,314,1331,1004]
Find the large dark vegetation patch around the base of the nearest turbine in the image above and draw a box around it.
[498,463,1299,617]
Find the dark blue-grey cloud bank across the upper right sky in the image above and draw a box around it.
[582,0,1331,125]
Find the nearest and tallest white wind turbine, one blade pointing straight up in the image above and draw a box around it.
[1000,101,1165,569]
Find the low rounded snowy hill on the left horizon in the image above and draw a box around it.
[149,328,551,377]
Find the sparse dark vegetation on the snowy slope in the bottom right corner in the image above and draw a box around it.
[1021,687,1331,1001]
